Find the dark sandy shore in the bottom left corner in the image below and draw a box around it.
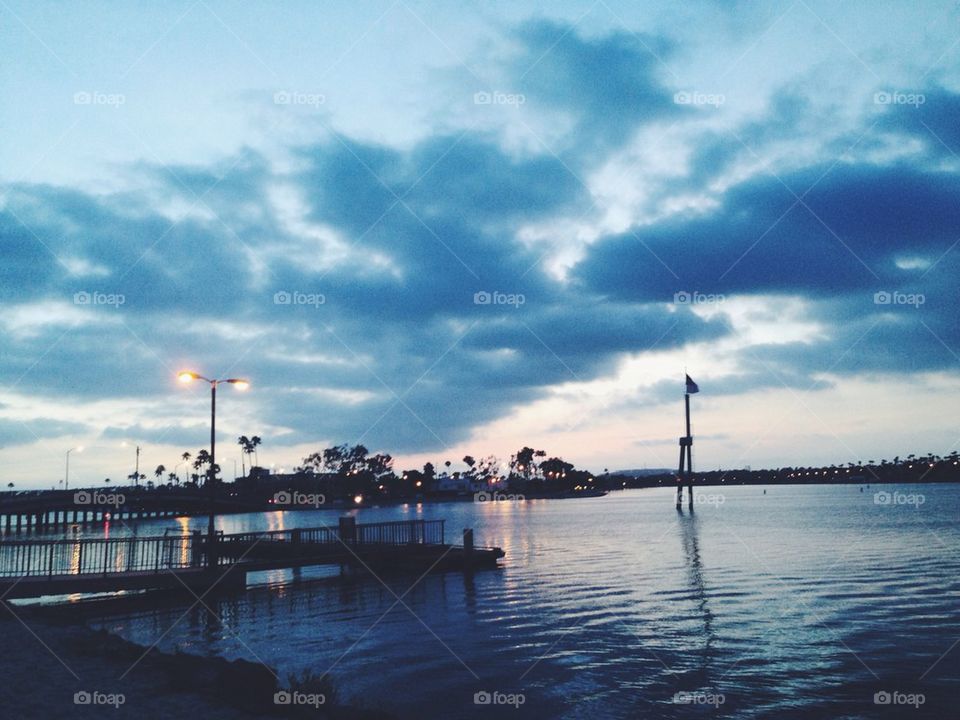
[0,604,384,720]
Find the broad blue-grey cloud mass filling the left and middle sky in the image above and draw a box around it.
[5,124,724,451]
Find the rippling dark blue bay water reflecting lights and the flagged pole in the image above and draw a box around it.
[77,485,960,718]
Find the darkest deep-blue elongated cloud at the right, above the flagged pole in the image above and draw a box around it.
[575,165,960,301]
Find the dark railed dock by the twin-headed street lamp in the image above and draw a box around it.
[0,517,504,599]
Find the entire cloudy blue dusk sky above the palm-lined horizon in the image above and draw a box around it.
[0,0,960,488]
